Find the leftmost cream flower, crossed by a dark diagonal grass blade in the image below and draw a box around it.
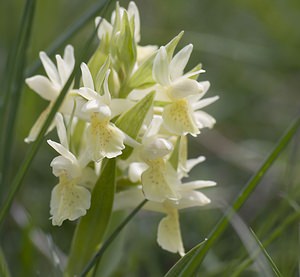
[25,45,75,143]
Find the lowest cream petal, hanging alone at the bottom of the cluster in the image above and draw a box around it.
[157,210,184,256]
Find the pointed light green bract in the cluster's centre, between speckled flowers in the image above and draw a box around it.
[116,91,155,158]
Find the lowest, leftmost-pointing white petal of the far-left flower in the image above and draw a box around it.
[26,75,59,101]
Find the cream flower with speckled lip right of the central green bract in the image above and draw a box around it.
[128,117,179,202]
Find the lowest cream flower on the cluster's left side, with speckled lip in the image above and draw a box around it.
[47,114,96,226]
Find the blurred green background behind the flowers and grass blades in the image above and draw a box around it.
[0,0,300,276]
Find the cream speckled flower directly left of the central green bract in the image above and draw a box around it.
[79,63,126,162]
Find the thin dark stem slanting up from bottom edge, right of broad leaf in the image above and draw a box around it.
[79,199,148,277]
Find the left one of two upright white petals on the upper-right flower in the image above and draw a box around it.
[152,46,171,86]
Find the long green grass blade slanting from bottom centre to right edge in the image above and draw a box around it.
[165,116,300,277]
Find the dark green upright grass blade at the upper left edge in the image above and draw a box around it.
[0,0,36,198]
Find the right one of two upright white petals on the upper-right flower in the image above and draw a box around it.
[170,44,193,80]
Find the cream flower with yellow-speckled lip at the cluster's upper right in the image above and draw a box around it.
[153,44,218,136]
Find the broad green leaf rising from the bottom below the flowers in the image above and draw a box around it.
[65,156,116,276]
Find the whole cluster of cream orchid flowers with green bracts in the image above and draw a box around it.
[25,2,218,255]
